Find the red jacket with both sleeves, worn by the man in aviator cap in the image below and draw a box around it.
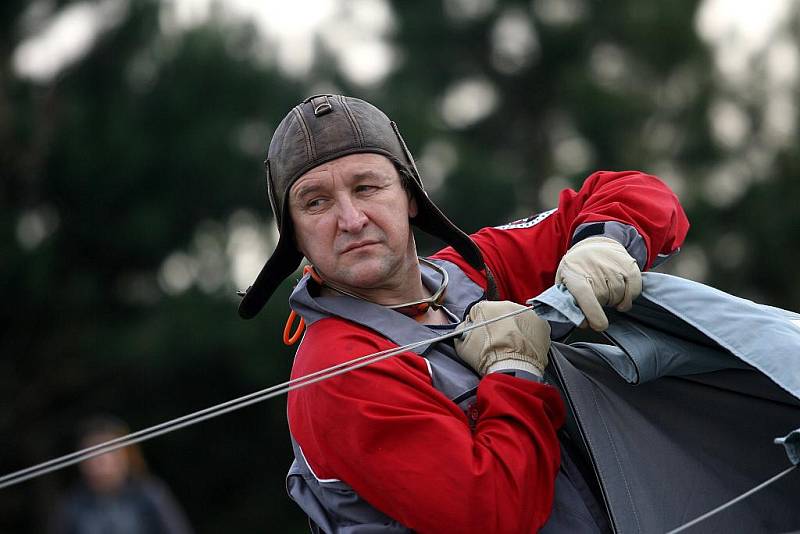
[288,172,688,533]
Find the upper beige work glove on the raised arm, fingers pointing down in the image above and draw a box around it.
[556,237,642,332]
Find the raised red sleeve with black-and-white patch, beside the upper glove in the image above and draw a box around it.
[434,171,689,302]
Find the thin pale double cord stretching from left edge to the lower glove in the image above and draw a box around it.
[0,305,533,489]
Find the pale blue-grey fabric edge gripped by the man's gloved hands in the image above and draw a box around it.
[531,273,800,398]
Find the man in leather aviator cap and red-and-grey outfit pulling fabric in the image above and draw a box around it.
[240,95,688,533]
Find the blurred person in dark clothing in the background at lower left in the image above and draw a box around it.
[50,416,192,534]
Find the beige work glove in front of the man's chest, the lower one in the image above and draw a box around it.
[455,300,550,376]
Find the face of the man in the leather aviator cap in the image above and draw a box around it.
[289,154,418,297]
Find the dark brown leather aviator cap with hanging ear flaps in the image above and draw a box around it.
[239,95,485,319]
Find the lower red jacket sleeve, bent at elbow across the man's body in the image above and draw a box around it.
[288,319,564,533]
